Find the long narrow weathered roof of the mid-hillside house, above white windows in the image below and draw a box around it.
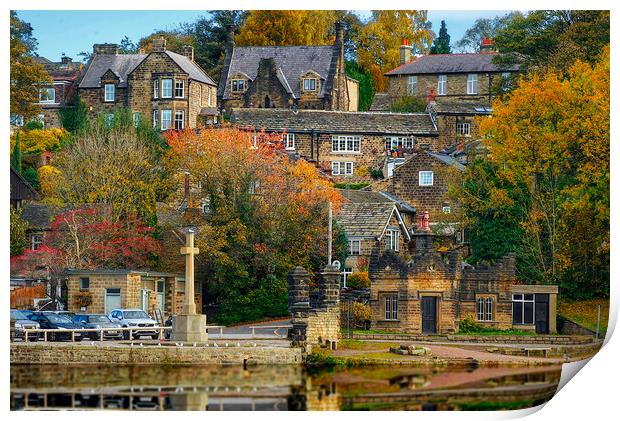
[230,108,437,135]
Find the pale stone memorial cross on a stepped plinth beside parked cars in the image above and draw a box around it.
[170,229,208,342]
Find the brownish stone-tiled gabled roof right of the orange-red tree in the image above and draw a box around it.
[336,203,409,239]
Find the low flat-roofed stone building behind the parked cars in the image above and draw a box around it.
[65,269,201,320]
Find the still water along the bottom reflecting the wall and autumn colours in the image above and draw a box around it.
[11,365,561,411]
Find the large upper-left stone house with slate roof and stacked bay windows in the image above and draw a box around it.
[78,37,217,130]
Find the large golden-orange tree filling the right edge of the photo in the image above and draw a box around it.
[462,47,610,298]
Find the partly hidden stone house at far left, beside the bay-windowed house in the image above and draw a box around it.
[36,56,84,128]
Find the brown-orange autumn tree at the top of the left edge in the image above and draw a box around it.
[9,10,51,120]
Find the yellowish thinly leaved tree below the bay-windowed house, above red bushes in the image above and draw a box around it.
[48,111,165,222]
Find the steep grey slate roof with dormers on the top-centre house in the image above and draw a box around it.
[223,45,334,99]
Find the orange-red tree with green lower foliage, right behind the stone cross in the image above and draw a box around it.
[167,128,340,323]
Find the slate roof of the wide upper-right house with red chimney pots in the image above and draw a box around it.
[385,53,519,76]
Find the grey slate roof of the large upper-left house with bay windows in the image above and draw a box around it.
[79,51,215,88]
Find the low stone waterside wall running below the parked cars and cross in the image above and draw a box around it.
[10,342,302,365]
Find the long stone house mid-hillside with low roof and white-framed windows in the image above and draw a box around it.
[230,108,438,181]
